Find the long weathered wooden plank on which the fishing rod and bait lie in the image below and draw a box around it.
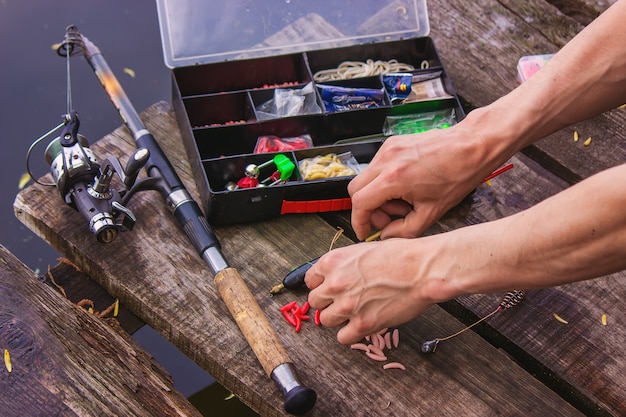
[15,103,580,416]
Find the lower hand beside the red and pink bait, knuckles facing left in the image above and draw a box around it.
[305,239,439,344]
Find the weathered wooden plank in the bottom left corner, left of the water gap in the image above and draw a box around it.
[0,246,199,417]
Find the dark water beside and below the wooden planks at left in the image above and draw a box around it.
[0,0,254,416]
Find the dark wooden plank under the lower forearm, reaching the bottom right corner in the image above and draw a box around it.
[431,155,626,416]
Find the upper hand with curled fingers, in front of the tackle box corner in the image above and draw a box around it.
[348,124,493,239]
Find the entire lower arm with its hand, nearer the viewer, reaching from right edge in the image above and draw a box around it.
[306,164,626,344]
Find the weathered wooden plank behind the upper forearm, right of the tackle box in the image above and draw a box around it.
[428,0,626,182]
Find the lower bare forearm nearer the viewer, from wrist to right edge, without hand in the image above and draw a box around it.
[442,164,626,298]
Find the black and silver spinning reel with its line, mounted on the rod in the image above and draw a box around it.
[26,26,159,243]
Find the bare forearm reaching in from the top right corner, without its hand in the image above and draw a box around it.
[466,0,626,166]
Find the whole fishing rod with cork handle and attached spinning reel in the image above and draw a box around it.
[36,25,317,415]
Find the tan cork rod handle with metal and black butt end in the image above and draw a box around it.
[214,267,317,415]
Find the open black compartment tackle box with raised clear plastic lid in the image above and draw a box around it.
[157,0,464,225]
